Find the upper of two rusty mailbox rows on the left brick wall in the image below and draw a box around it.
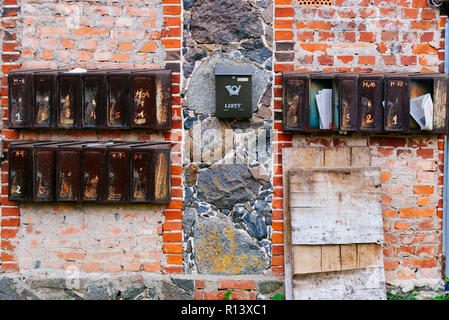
[8,69,172,130]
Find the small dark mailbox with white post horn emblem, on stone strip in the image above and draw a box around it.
[215,66,253,118]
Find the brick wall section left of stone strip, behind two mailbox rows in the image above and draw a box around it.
[1,0,183,273]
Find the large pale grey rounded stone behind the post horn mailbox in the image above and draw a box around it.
[186,54,270,114]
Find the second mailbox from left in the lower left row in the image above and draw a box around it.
[33,141,77,202]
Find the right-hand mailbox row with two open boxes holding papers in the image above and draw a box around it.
[283,72,449,134]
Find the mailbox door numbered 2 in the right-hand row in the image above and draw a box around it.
[359,76,384,132]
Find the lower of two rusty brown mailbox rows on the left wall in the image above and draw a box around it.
[8,141,171,204]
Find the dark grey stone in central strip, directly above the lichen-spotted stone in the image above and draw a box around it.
[198,164,261,209]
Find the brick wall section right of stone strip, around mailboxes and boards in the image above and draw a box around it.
[273,0,444,288]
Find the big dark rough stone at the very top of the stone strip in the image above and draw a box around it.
[191,0,263,44]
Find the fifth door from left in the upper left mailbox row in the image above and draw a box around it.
[106,74,130,128]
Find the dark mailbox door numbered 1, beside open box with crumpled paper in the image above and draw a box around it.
[384,76,410,132]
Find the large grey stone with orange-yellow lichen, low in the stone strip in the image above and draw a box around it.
[193,212,269,275]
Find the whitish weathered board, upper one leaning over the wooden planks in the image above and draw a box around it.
[289,167,383,245]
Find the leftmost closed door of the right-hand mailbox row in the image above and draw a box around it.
[283,74,310,131]
